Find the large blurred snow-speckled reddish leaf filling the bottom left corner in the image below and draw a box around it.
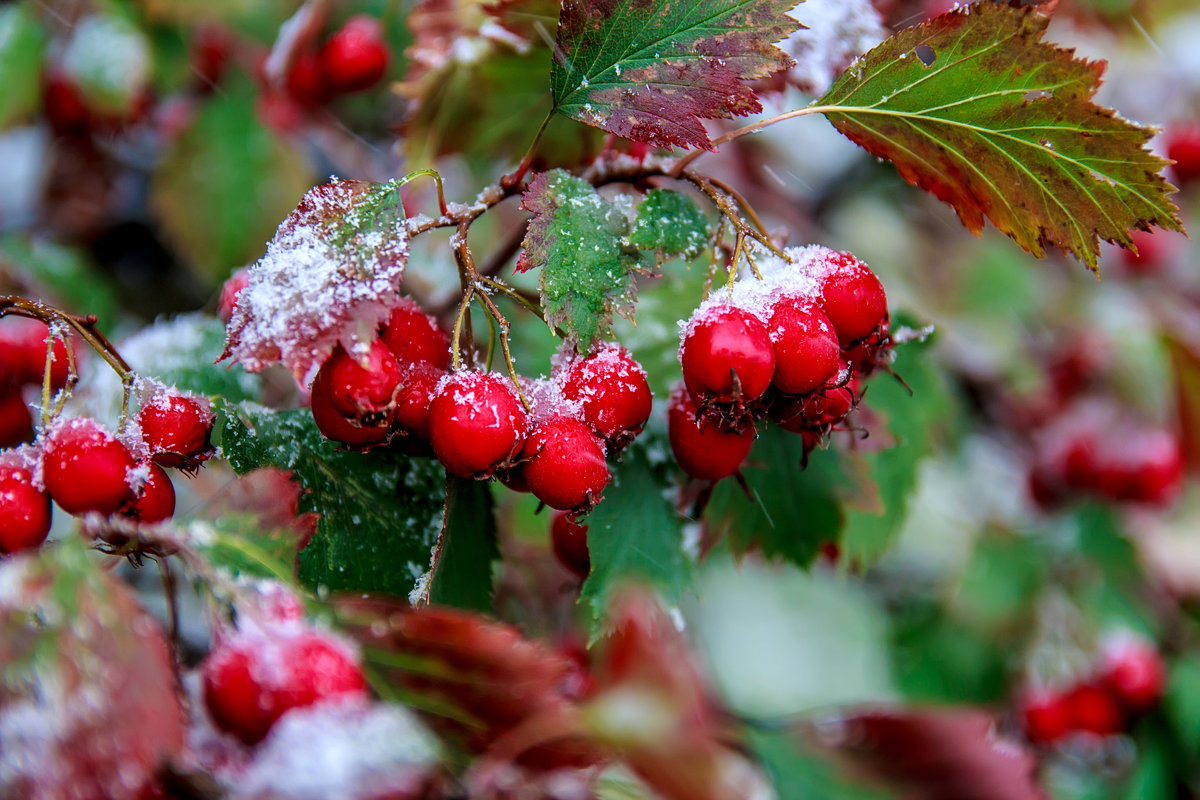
[0,537,184,800]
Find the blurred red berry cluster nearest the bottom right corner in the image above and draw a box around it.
[1018,637,1166,744]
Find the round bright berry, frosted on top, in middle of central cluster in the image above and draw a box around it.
[430,372,528,477]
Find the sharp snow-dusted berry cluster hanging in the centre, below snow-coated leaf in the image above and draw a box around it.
[304,300,652,513]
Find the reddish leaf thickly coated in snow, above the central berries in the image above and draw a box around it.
[222,180,408,385]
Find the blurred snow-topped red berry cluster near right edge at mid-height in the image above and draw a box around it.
[1030,402,1184,509]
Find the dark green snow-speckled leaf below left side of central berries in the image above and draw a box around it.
[221,404,445,596]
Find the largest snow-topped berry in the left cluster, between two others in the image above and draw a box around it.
[42,417,134,515]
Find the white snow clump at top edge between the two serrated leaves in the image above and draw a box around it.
[780,0,888,95]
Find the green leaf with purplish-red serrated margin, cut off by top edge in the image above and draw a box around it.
[551,0,799,149]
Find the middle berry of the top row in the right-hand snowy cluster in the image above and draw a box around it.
[767,295,841,395]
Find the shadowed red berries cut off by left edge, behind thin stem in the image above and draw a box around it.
[0,317,70,447]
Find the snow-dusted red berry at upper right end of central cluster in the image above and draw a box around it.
[562,344,653,444]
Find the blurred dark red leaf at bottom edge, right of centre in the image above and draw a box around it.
[839,709,1045,800]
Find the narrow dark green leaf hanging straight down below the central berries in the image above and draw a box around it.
[428,476,500,612]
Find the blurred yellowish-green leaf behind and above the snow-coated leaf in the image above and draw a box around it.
[151,82,312,283]
